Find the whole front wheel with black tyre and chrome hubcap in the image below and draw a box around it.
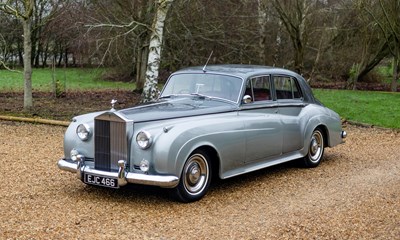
[172,150,212,202]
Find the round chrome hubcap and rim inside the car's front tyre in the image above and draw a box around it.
[183,154,209,195]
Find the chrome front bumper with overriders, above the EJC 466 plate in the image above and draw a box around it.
[57,157,179,188]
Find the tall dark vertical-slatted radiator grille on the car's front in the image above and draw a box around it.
[94,118,128,171]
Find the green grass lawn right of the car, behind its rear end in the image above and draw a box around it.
[313,89,400,129]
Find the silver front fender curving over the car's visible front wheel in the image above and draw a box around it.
[148,116,245,177]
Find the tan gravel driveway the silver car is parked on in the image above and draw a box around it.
[0,121,400,239]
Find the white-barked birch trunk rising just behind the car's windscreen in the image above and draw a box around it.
[142,0,173,102]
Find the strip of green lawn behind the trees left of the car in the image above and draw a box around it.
[0,68,135,91]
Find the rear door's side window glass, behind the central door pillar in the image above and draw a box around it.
[274,76,302,99]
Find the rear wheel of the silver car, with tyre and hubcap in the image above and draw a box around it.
[303,128,325,167]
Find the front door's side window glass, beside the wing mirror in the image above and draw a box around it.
[246,76,272,102]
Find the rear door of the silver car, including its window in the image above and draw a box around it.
[272,75,305,154]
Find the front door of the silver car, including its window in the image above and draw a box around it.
[238,75,283,163]
